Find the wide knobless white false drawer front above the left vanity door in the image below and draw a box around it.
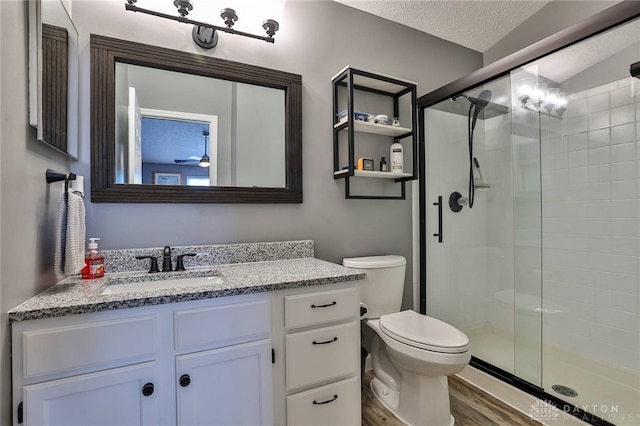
[22,315,157,378]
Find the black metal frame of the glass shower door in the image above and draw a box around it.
[417,1,640,425]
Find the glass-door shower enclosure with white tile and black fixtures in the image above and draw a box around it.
[418,2,640,425]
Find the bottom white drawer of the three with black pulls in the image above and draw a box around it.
[287,376,361,426]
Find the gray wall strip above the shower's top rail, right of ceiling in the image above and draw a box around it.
[484,0,620,65]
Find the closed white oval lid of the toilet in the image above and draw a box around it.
[380,310,469,353]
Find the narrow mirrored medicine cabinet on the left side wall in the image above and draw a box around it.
[29,0,79,159]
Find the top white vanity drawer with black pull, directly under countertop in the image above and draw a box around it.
[284,286,360,330]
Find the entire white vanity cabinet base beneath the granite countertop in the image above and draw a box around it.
[11,282,360,426]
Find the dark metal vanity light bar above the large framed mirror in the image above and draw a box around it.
[124,0,280,49]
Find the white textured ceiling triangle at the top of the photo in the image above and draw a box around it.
[335,0,550,52]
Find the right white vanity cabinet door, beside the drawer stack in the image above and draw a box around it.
[176,339,273,426]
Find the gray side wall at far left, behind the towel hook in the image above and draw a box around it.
[0,0,69,425]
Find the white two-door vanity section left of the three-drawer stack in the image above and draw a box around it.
[12,294,273,426]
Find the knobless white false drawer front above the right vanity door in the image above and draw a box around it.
[174,299,271,349]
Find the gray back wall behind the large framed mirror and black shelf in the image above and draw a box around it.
[74,1,482,306]
